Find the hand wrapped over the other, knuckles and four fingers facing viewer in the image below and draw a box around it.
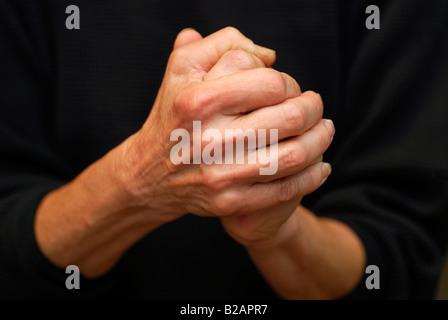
[117,28,332,221]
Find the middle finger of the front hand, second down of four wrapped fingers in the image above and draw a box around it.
[233,91,323,141]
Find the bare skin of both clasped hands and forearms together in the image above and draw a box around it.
[35,28,366,299]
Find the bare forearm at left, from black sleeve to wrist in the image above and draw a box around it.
[35,136,180,277]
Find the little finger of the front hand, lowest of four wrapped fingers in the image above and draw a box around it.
[240,162,331,211]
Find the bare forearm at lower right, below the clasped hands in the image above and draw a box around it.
[247,206,366,299]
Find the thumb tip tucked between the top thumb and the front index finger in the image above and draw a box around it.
[204,50,265,80]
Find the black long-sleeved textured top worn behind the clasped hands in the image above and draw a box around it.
[0,0,448,299]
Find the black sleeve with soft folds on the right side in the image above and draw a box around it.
[306,1,448,299]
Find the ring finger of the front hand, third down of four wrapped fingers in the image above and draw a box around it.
[215,120,334,184]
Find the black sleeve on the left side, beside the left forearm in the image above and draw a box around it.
[0,0,117,298]
